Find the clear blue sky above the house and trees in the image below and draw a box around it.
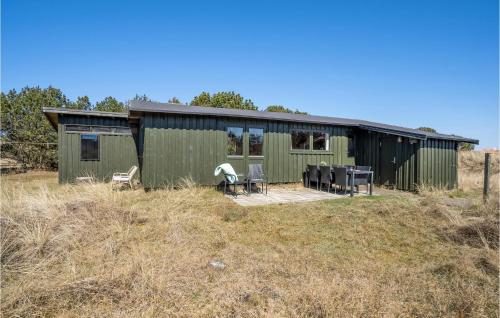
[1,0,499,147]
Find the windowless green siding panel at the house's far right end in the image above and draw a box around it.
[417,139,458,189]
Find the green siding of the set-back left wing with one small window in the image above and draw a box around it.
[58,115,139,182]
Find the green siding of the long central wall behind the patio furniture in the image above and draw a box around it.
[140,113,354,188]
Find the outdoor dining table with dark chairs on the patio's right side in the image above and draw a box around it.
[304,165,373,197]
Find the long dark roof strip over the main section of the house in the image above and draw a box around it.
[129,101,479,144]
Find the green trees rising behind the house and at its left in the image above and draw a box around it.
[0,86,306,169]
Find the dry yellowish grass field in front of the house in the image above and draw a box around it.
[0,153,499,317]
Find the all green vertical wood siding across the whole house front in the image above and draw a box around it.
[54,113,458,190]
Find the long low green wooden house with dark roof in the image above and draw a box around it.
[44,101,478,190]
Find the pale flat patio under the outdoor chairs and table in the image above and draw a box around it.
[226,188,376,206]
